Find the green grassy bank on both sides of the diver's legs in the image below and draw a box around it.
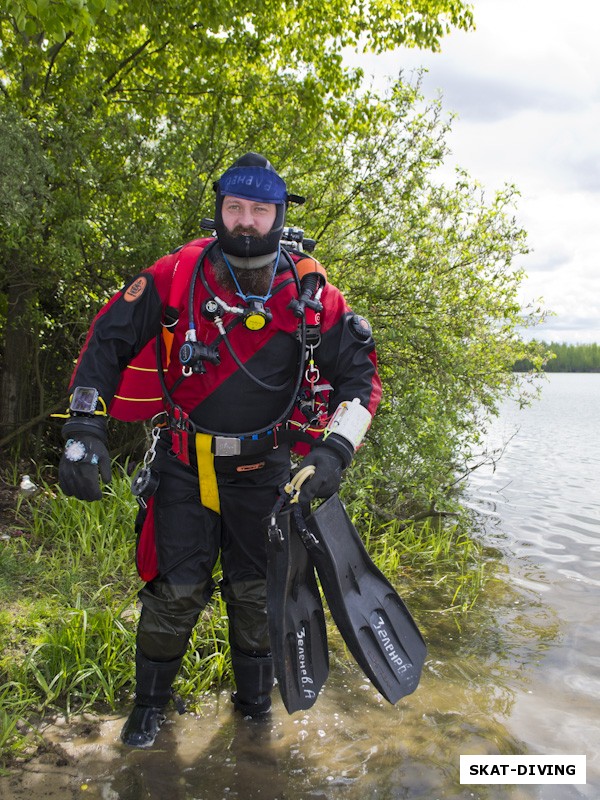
[0,466,484,764]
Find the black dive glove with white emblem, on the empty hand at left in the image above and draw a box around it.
[58,417,110,500]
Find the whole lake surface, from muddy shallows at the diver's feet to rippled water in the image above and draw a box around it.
[0,375,600,800]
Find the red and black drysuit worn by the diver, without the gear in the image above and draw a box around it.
[71,240,381,705]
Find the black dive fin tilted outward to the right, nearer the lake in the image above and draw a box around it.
[294,494,427,703]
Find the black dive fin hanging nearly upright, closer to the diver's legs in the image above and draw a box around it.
[267,511,329,714]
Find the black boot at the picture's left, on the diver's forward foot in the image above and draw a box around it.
[121,651,181,747]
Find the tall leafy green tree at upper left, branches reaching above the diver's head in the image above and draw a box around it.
[0,0,472,438]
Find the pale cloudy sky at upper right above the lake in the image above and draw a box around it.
[350,0,600,343]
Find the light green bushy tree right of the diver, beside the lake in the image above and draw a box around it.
[274,81,547,516]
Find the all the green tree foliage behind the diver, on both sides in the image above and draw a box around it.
[0,0,543,513]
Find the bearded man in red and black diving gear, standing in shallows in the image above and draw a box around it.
[59,153,381,747]
